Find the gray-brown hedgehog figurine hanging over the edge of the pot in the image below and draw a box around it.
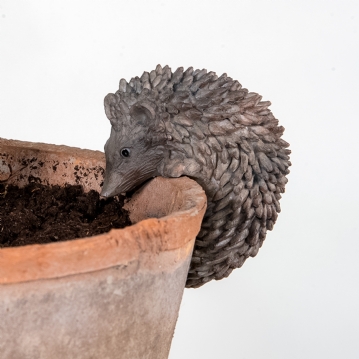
[101,65,291,287]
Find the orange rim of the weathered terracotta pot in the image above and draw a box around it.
[0,138,206,284]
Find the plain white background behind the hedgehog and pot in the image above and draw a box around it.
[0,0,359,359]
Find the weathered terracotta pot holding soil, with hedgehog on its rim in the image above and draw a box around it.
[0,139,206,359]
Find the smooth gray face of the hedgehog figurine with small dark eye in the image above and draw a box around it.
[101,95,164,197]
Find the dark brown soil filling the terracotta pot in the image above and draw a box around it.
[0,183,131,248]
